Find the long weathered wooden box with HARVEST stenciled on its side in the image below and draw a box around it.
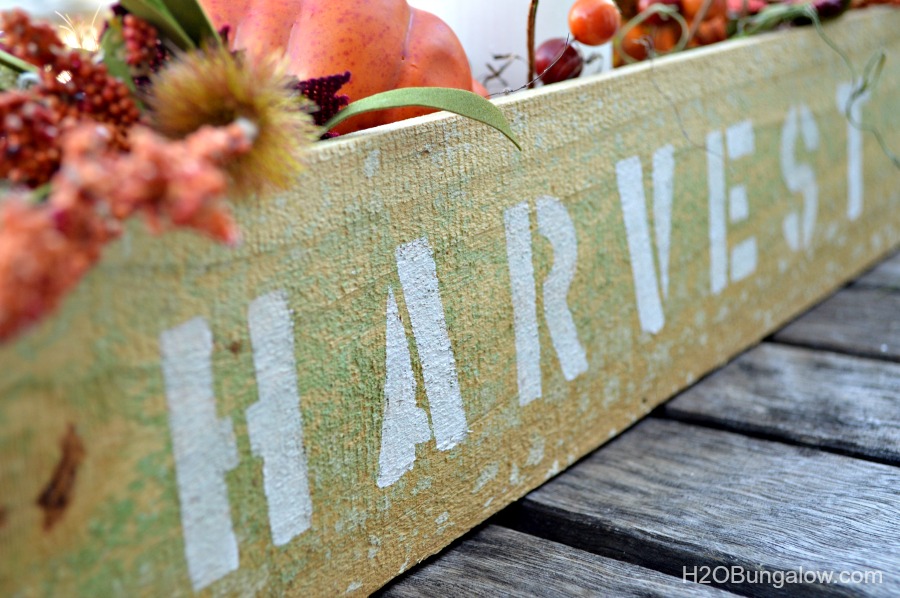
[0,10,900,596]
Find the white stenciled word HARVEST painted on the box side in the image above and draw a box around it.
[160,84,867,590]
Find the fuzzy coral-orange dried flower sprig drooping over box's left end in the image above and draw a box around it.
[0,122,254,341]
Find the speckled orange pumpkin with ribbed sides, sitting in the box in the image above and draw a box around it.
[201,0,473,133]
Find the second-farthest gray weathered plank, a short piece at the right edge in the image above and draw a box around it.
[772,288,900,360]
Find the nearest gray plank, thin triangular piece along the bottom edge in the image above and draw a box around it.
[380,525,734,598]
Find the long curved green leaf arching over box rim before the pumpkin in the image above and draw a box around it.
[324,87,522,150]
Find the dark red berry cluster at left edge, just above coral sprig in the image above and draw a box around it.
[0,92,60,187]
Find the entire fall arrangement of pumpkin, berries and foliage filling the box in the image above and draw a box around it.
[0,0,897,341]
